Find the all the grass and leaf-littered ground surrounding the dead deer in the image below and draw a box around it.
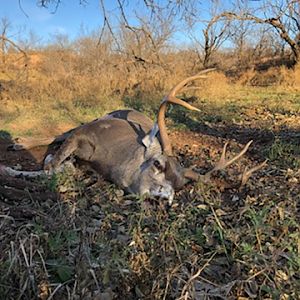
[0,49,300,300]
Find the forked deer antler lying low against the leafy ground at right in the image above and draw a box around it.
[184,141,267,186]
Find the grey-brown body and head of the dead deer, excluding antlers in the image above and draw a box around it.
[45,110,174,201]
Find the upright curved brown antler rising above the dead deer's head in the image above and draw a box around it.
[157,68,215,156]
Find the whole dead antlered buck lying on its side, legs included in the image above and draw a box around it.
[0,69,265,204]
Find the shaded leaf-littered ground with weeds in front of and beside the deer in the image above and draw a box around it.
[0,114,300,300]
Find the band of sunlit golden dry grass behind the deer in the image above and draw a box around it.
[0,51,300,136]
